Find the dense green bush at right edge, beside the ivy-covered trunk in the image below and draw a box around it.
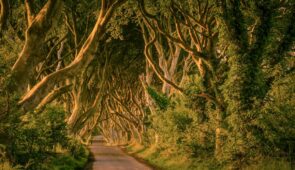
[256,74,295,157]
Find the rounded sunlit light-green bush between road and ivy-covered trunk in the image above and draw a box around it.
[151,97,212,156]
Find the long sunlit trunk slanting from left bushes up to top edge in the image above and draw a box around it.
[19,0,126,110]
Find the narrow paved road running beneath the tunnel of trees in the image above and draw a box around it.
[86,136,151,170]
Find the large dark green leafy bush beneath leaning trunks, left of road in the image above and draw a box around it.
[7,107,68,169]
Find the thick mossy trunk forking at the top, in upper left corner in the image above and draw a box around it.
[11,0,62,93]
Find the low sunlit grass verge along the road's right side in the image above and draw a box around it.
[126,144,292,170]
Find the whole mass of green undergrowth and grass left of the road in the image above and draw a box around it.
[0,106,89,170]
